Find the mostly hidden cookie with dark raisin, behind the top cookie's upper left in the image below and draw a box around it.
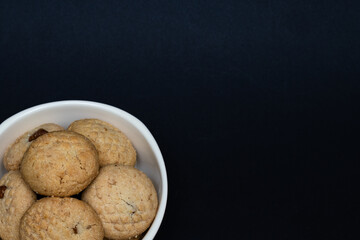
[3,123,64,171]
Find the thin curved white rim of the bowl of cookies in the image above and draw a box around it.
[0,100,168,240]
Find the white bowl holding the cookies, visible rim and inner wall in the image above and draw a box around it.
[0,101,168,240]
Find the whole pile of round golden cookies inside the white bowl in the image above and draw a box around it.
[0,119,158,240]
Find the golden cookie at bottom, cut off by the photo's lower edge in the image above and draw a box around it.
[20,197,104,240]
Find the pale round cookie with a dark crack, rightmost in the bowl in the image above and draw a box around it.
[82,165,158,239]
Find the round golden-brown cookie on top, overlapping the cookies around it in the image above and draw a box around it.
[20,131,99,197]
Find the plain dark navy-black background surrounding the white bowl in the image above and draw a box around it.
[0,0,360,240]
